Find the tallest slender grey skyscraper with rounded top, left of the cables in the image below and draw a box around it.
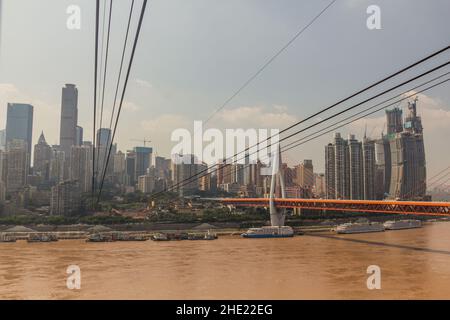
[59,84,78,163]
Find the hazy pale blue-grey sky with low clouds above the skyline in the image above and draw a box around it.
[0,0,450,176]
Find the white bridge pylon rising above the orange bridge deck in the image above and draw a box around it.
[269,144,286,227]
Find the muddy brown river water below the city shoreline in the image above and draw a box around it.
[0,222,450,299]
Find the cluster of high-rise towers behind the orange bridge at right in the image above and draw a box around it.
[325,99,428,200]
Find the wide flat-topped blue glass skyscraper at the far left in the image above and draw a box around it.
[6,103,33,167]
